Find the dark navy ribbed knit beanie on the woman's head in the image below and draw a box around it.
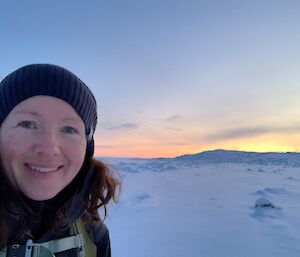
[0,64,97,157]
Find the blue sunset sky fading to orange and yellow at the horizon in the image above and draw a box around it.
[0,0,300,157]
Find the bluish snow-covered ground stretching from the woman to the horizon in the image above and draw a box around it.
[99,152,300,257]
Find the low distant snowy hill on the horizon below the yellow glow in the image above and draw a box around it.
[175,150,300,167]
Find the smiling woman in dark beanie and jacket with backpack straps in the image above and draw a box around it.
[0,64,119,257]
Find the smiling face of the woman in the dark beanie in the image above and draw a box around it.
[0,96,87,201]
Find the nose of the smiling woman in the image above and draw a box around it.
[34,131,60,157]
